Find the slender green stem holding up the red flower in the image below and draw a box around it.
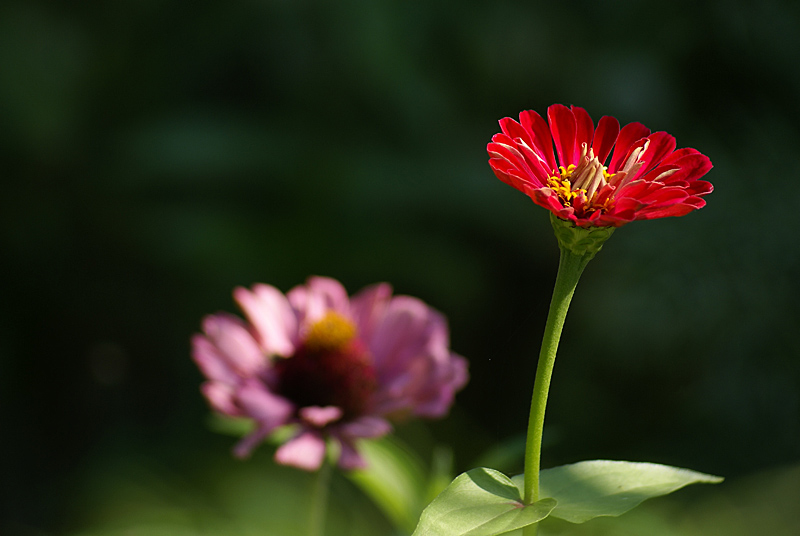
[523,247,594,536]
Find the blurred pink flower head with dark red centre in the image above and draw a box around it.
[192,277,468,471]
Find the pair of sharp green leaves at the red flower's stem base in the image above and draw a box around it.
[412,460,723,536]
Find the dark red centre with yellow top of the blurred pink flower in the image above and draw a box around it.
[275,312,377,418]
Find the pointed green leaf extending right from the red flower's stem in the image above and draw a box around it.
[514,460,723,523]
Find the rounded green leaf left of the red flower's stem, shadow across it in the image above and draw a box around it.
[412,468,556,536]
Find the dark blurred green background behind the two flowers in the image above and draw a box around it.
[0,0,800,536]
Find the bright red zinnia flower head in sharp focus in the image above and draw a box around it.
[487,104,713,227]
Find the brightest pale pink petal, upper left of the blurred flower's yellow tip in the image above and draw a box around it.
[233,284,297,357]
